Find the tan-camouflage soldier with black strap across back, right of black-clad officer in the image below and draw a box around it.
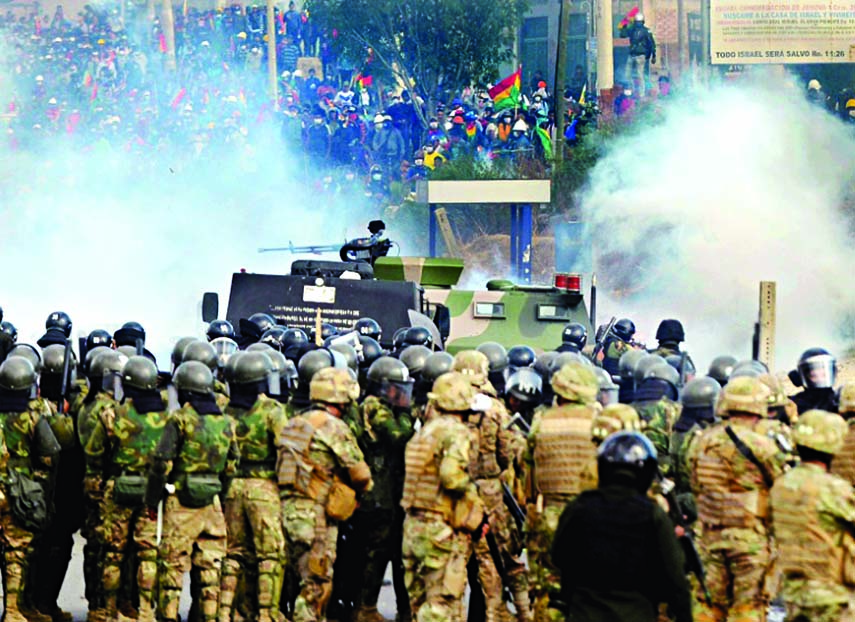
[687,377,785,622]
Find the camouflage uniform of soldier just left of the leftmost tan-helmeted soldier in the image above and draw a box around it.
[218,395,287,622]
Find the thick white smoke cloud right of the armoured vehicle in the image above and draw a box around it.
[582,73,855,370]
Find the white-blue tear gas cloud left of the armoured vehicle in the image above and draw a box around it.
[0,36,382,367]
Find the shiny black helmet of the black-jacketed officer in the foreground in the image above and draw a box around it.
[597,431,658,494]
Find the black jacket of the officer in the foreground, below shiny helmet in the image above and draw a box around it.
[552,484,692,622]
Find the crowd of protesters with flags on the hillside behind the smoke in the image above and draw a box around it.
[0,2,597,200]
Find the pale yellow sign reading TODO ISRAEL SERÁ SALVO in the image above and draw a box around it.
[710,0,855,65]
